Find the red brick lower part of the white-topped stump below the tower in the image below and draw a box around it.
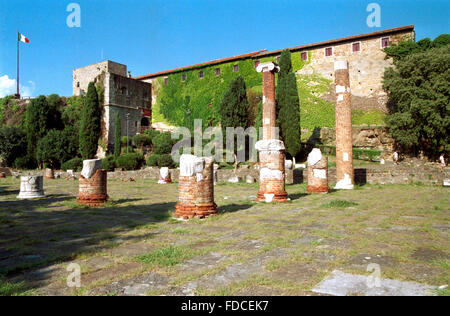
[77,169,108,206]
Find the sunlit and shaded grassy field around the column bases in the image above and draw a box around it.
[0,178,450,295]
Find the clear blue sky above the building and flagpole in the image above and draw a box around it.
[0,0,450,96]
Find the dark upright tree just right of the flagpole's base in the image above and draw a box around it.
[25,95,54,158]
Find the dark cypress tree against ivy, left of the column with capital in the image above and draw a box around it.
[219,76,250,168]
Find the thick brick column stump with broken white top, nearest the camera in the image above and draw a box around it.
[174,155,217,219]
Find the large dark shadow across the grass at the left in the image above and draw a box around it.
[0,199,179,287]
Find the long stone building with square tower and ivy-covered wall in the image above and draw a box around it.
[73,25,415,153]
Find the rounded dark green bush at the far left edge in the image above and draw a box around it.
[0,126,27,167]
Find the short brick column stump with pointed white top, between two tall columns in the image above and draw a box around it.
[306,148,330,194]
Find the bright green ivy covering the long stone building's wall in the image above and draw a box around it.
[152,52,384,137]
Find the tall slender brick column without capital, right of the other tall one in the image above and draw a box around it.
[334,60,354,189]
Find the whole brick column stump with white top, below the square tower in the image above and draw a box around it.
[77,159,108,206]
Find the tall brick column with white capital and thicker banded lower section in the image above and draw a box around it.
[256,62,287,202]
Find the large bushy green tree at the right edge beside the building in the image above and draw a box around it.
[383,45,450,157]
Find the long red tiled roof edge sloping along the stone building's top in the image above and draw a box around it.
[133,25,414,80]
